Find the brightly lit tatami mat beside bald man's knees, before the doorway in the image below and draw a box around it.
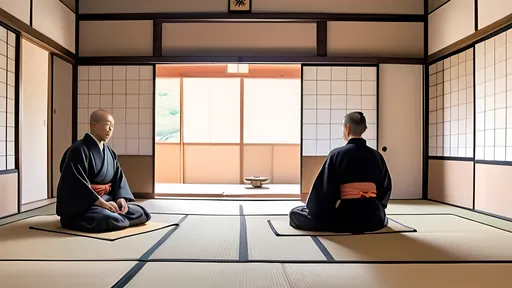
[138,199,240,215]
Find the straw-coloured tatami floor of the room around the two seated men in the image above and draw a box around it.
[0,199,512,288]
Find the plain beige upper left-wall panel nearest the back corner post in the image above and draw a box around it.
[32,0,75,53]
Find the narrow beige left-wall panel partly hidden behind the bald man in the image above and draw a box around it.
[52,56,73,196]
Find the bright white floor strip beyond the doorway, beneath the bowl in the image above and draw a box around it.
[155,183,300,198]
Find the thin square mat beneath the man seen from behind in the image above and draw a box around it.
[269,218,416,237]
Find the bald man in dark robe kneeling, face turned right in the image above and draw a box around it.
[57,110,151,233]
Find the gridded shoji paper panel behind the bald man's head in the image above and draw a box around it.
[78,66,153,155]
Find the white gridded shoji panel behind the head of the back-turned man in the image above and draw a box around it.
[302,66,377,156]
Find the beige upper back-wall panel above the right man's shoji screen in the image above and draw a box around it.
[327,21,424,57]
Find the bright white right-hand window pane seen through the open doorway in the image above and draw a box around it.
[244,79,301,144]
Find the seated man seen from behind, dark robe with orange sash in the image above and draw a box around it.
[289,112,391,233]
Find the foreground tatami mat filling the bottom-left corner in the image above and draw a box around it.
[0,261,135,288]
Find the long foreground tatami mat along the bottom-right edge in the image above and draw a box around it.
[284,264,512,288]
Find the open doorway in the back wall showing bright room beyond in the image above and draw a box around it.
[155,63,301,198]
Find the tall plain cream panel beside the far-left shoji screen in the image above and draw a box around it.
[20,40,49,204]
